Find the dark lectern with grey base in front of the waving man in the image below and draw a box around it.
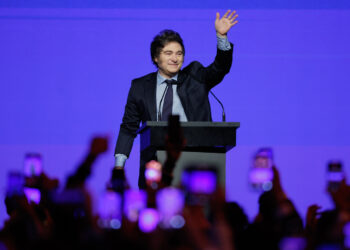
[138,121,240,187]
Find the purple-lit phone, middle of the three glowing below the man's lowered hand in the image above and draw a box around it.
[123,189,147,222]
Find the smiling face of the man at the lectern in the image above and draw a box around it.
[154,42,184,78]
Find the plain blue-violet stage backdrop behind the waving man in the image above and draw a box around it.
[0,0,350,227]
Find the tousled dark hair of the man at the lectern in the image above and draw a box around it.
[151,30,185,67]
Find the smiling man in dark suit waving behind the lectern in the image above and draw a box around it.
[115,10,238,186]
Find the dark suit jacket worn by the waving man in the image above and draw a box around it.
[115,44,233,157]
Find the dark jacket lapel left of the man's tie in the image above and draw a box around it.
[145,73,157,121]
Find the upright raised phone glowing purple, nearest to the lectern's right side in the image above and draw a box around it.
[249,148,273,191]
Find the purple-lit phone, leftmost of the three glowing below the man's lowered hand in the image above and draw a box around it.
[98,190,122,229]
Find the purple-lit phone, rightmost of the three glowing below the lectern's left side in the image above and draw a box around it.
[156,187,185,229]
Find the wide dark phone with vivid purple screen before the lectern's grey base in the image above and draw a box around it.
[182,166,217,205]
